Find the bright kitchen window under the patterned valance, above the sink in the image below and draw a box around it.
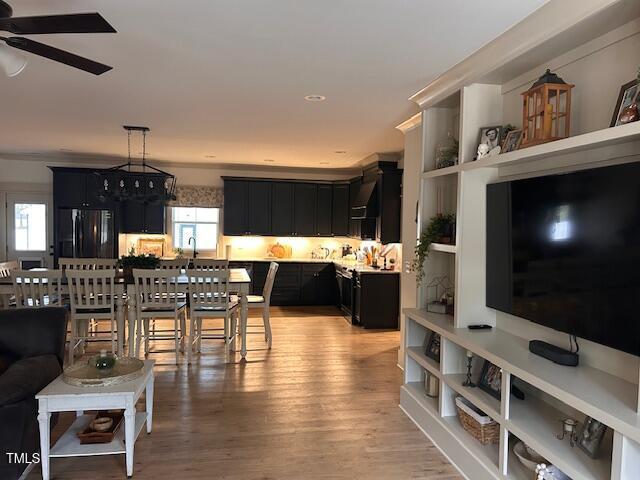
[171,207,220,251]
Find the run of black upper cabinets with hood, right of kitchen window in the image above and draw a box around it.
[223,166,402,243]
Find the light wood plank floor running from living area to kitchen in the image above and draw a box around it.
[29,308,461,480]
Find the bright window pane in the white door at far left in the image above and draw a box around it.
[14,203,47,252]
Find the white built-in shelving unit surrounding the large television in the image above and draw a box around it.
[399,0,640,480]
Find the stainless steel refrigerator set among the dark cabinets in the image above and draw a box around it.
[55,208,116,264]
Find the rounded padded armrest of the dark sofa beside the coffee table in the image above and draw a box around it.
[0,355,62,406]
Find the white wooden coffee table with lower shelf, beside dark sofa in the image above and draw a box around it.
[36,360,155,480]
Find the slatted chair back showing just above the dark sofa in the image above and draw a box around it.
[11,270,62,307]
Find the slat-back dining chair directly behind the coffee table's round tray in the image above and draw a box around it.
[67,269,117,365]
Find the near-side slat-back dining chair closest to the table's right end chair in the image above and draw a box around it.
[187,261,240,363]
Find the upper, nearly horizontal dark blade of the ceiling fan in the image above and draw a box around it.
[0,13,116,35]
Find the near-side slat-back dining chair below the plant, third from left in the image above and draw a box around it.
[133,268,187,364]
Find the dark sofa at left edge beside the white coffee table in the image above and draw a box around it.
[0,307,67,480]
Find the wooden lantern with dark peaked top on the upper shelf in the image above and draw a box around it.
[522,70,574,148]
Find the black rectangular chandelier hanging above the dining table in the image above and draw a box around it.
[97,125,176,204]
